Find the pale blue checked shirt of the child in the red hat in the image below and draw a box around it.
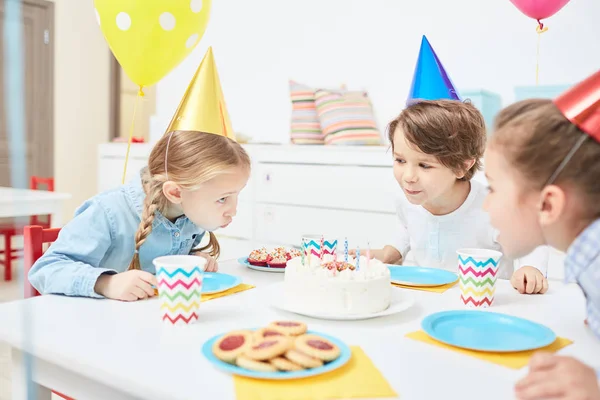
[565,219,600,339]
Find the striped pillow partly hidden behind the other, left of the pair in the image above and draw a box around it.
[290,81,325,144]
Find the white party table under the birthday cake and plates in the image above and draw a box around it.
[0,262,600,400]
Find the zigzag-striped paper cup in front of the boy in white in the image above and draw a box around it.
[457,249,502,308]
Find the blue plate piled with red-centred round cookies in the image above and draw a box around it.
[202,321,351,380]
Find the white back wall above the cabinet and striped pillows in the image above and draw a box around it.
[150,0,600,142]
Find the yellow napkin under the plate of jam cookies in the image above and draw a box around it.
[234,346,398,400]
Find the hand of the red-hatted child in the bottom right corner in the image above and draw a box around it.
[515,353,600,400]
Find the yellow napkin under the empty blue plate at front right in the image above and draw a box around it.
[406,331,573,369]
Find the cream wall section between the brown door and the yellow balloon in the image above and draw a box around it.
[54,0,110,222]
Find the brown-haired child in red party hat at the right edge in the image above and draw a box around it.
[484,71,600,400]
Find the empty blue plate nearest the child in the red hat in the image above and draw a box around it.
[421,311,556,353]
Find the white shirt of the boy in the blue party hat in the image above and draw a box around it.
[392,181,549,279]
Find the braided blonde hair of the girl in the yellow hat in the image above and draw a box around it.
[128,131,250,270]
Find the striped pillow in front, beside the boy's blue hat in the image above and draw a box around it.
[315,89,381,145]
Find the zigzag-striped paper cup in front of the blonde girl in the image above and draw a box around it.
[153,255,206,325]
